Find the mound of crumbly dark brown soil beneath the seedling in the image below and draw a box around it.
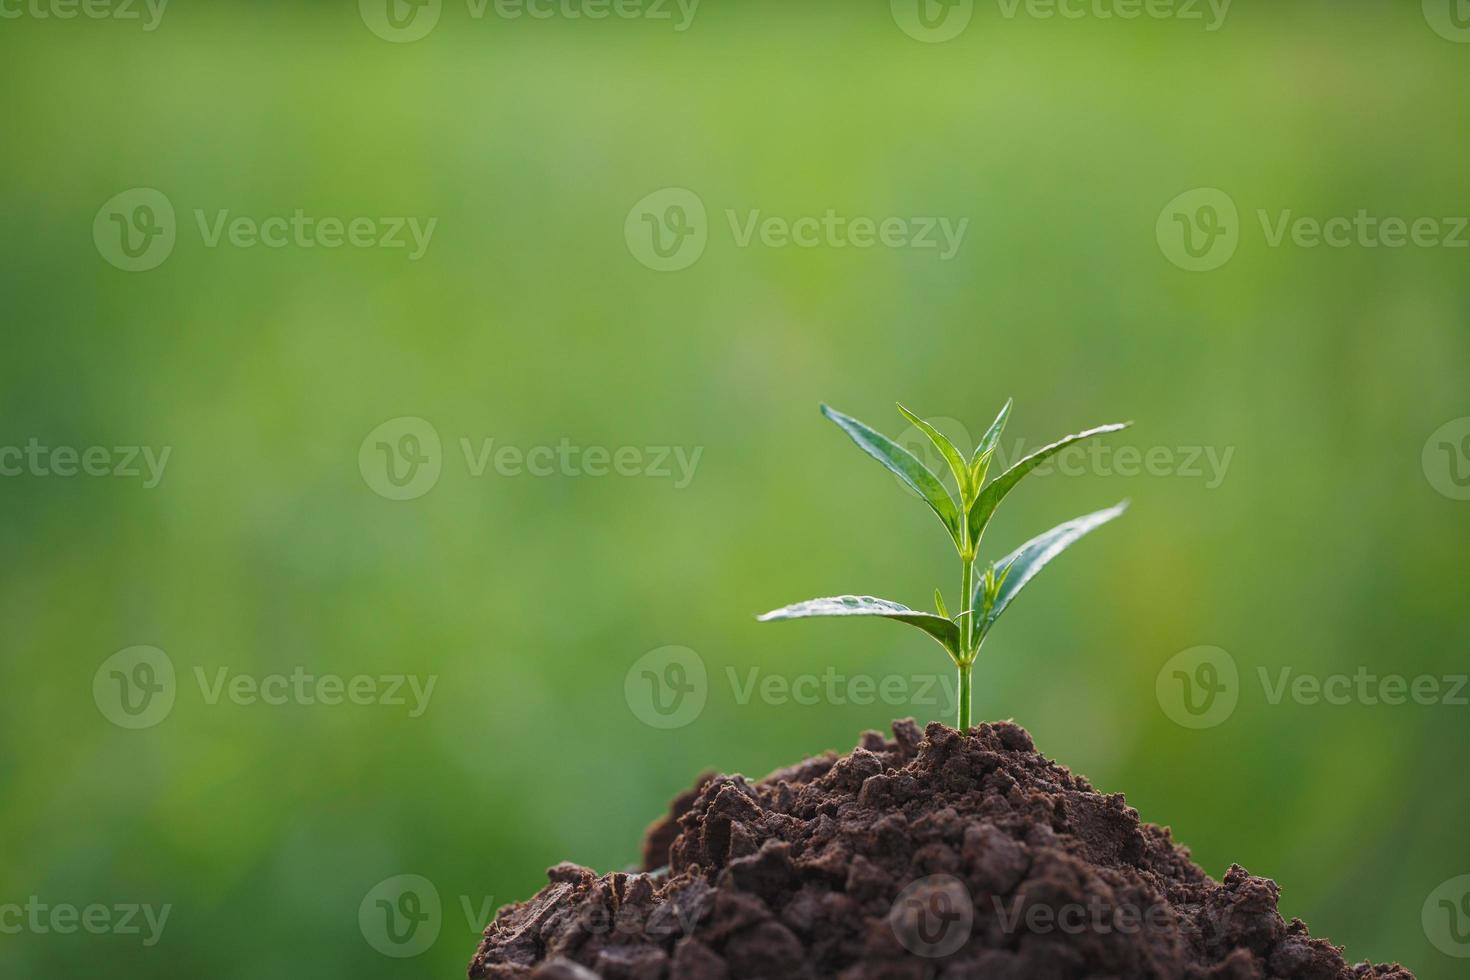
[469,721,1413,980]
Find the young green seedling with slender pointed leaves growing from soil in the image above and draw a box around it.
[759,401,1129,732]
